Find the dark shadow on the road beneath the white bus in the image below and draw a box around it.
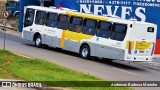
[25,43,145,71]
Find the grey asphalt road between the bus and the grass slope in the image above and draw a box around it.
[0,31,160,90]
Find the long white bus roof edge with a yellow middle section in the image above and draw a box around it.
[27,6,155,25]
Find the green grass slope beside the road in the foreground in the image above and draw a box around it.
[0,50,133,90]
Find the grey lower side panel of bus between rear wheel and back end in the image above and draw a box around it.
[79,37,125,60]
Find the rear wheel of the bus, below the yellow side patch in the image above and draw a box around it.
[80,45,90,59]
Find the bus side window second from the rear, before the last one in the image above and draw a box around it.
[97,21,112,38]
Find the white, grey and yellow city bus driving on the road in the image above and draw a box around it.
[22,6,157,61]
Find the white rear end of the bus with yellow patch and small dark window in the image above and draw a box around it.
[124,22,157,61]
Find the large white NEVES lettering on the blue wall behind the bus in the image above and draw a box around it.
[80,4,146,21]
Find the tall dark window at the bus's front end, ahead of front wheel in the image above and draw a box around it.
[24,9,35,27]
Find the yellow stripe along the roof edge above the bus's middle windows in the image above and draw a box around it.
[66,11,108,21]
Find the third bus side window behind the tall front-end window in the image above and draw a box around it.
[57,14,70,30]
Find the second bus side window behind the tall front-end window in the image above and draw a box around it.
[46,13,58,28]
